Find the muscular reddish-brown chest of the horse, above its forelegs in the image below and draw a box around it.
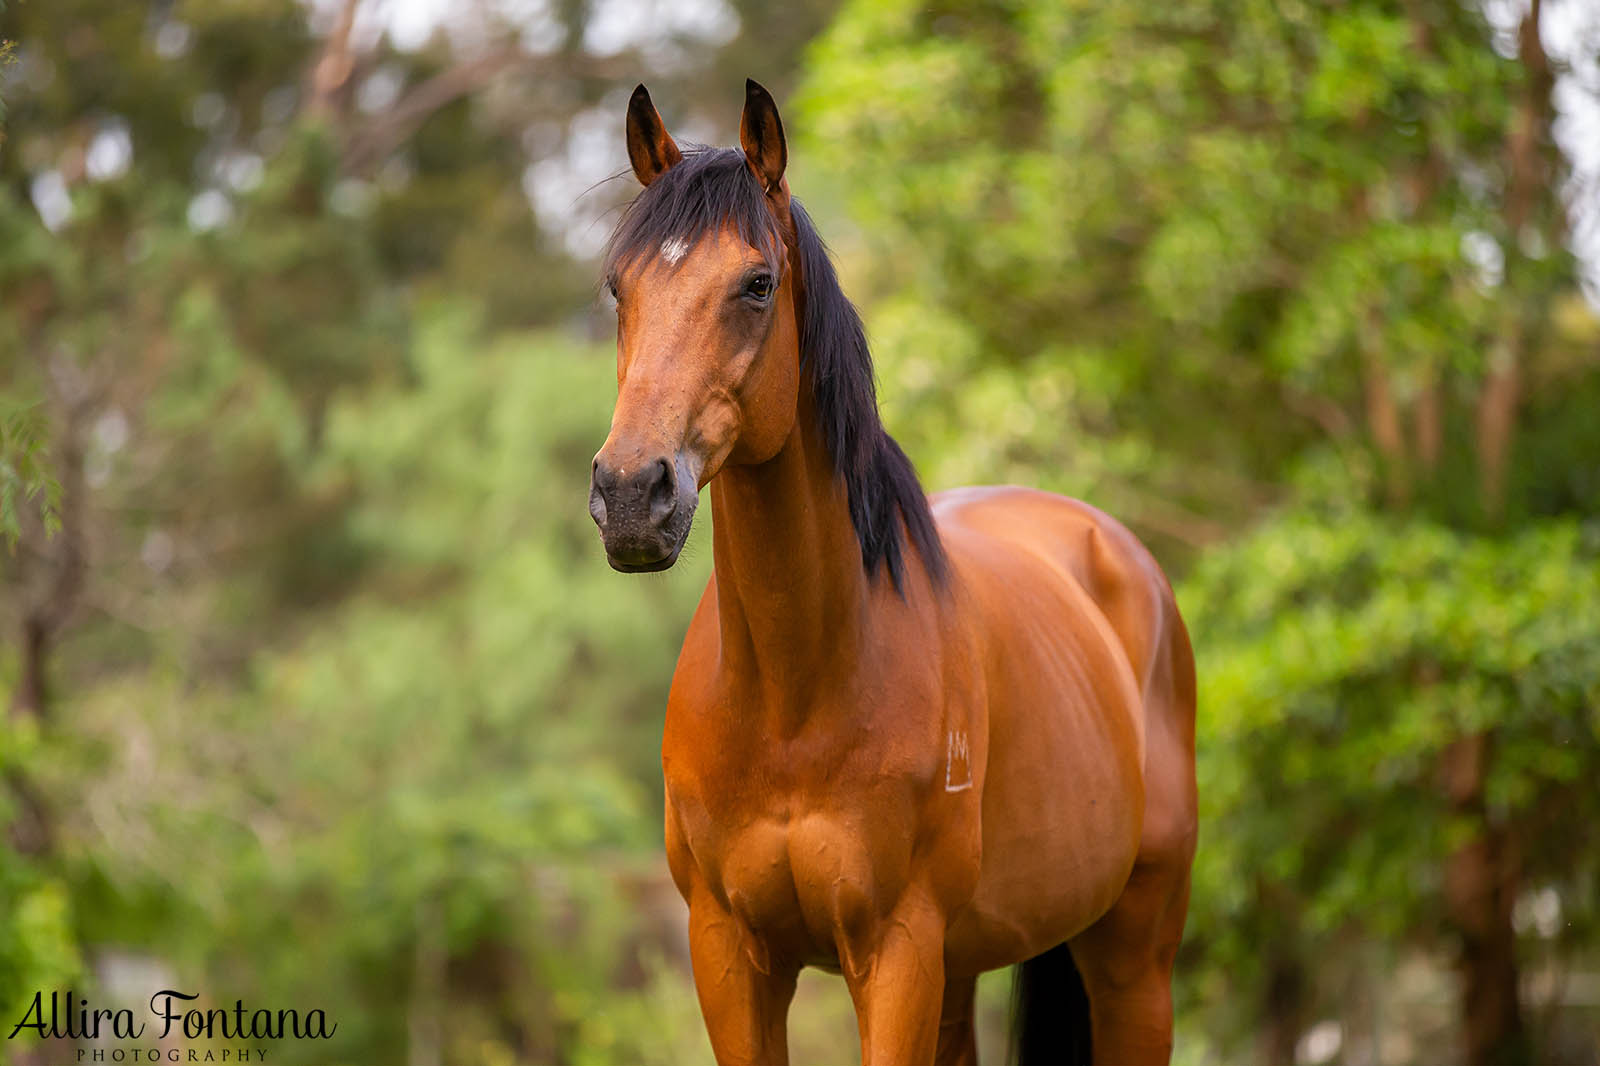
[662,665,971,965]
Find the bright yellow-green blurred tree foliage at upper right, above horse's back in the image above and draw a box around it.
[794,0,1597,551]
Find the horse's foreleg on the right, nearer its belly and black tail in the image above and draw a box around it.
[840,890,944,1066]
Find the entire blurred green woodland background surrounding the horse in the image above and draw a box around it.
[0,0,1600,1066]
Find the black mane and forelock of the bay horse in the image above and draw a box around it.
[605,147,947,589]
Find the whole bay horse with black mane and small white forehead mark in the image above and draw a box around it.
[589,82,1197,1064]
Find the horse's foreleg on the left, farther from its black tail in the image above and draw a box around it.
[690,890,798,1066]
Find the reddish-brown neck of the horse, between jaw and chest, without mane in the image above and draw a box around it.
[710,389,869,703]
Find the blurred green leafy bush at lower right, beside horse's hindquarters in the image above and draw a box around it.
[1181,507,1600,1050]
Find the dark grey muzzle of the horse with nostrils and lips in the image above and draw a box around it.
[589,450,699,573]
